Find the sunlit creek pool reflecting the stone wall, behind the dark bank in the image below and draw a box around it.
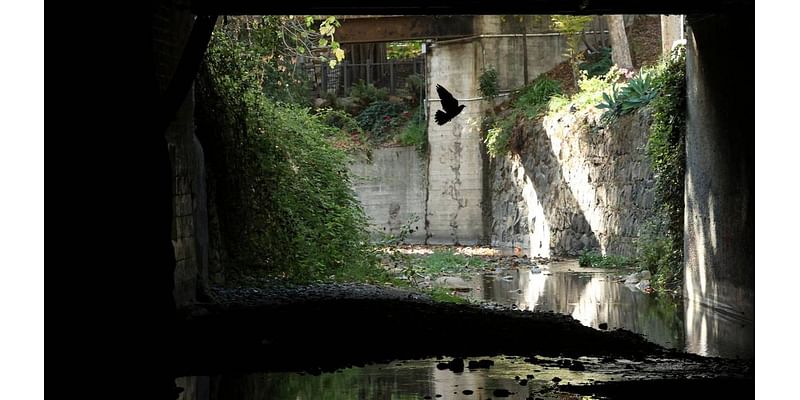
[467,261,755,358]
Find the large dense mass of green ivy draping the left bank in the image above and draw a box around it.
[198,22,381,282]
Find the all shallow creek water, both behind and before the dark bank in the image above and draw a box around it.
[177,261,753,400]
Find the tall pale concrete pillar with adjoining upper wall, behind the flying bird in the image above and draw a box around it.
[416,15,584,244]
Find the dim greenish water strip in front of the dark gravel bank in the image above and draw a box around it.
[176,357,580,400]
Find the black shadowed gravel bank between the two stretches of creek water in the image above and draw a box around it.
[173,285,732,376]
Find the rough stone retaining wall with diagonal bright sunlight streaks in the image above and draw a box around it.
[492,110,654,257]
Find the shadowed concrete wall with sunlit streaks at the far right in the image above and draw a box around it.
[684,15,755,356]
